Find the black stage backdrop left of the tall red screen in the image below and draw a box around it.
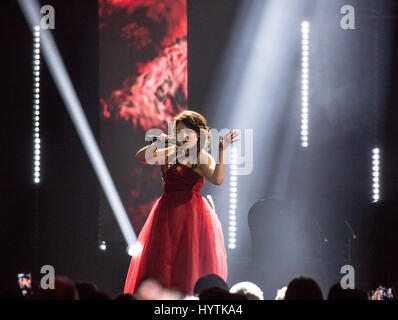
[1,0,107,287]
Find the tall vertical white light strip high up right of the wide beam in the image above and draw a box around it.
[301,21,310,148]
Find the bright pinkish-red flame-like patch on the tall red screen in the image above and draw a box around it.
[101,40,187,130]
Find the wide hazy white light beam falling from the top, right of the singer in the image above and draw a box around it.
[206,0,310,252]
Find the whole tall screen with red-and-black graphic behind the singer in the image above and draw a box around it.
[99,0,188,232]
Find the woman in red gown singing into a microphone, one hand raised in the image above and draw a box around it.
[124,110,239,295]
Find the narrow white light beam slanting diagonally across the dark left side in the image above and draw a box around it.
[18,0,137,247]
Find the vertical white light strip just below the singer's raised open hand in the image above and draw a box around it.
[228,148,238,250]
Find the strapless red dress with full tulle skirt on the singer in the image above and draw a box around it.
[124,164,227,295]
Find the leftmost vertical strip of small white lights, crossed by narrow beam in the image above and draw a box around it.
[33,26,41,184]
